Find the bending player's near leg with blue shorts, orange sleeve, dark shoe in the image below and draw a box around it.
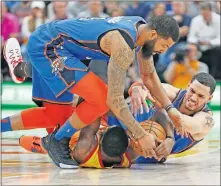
[25,30,108,168]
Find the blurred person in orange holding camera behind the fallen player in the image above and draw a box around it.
[163,44,208,89]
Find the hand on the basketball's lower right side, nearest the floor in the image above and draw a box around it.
[155,138,175,161]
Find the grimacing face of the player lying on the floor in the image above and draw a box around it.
[184,80,212,111]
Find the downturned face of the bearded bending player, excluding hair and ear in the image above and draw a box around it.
[153,36,174,54]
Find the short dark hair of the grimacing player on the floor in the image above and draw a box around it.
[191,72,216,94]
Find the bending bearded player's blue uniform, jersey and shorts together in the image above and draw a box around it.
[27,17,146,104]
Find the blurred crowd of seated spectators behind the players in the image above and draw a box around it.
[1,0,221,94]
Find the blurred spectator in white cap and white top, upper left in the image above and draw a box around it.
[21,1,45,61]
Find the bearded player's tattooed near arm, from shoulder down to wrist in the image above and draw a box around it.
[103,31,145,139]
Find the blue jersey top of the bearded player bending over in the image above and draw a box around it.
[47,16,146,62]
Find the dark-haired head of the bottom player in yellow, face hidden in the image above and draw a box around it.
[101,126,128,157]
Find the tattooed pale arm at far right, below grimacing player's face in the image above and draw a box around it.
[183,112,215,136]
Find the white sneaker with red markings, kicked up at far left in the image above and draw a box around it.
[3,38,25,83]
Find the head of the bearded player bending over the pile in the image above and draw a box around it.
[142,15,179,57]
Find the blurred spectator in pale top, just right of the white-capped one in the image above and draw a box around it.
[47,1,68,22]
